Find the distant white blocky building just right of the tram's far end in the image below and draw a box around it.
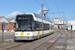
[53,18,66,29]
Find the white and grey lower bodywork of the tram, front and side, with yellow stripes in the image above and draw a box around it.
[14,30,52,40]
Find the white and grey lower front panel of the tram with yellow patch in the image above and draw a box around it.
[14,32,33,40]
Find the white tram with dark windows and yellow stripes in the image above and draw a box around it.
[14,13,54,40]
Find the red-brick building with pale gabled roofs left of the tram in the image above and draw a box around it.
[0,16,15,32]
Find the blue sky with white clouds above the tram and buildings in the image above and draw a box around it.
[0,0,75,21]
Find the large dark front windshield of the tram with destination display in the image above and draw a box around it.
[16,15,32,30]
